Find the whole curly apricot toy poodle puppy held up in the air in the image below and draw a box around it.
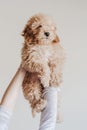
[22,14,65,116]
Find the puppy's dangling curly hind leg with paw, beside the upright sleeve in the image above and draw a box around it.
[22,72,46,117]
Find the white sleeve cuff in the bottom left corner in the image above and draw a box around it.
[0,106,12,130]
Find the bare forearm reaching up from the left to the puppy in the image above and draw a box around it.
[1,68,25,111]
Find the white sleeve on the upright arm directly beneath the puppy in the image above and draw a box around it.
[39,87,58,130]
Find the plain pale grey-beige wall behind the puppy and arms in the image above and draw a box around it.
[0,0,87,130]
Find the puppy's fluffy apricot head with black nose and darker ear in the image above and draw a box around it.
[22,14,59,45]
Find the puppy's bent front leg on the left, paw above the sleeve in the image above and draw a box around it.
[22,53,50,87]
